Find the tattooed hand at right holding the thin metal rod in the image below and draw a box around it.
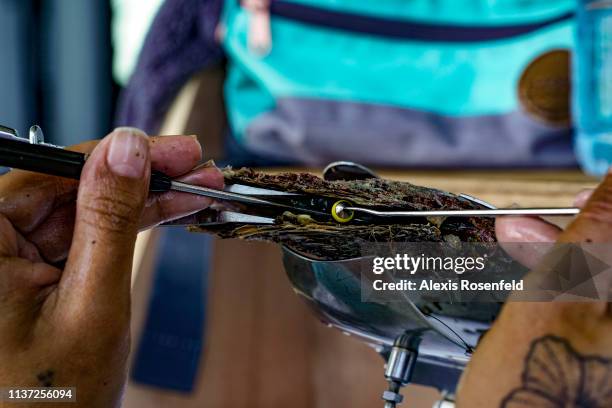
[457,173,612,408]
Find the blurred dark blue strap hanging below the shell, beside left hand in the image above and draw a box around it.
[131,228,212,392]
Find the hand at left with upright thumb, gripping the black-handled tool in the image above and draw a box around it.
[0,129,223,407]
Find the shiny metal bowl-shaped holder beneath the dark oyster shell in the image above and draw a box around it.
[283,247,500,393]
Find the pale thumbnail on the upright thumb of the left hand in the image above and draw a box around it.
[106,127,149,178]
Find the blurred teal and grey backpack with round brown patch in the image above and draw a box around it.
[217,0,575,167]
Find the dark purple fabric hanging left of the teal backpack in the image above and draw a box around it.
[117,0,223,133]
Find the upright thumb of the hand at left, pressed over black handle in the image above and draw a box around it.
[58,128,151,322]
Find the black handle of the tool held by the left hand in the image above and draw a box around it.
[0,139,172,192]
